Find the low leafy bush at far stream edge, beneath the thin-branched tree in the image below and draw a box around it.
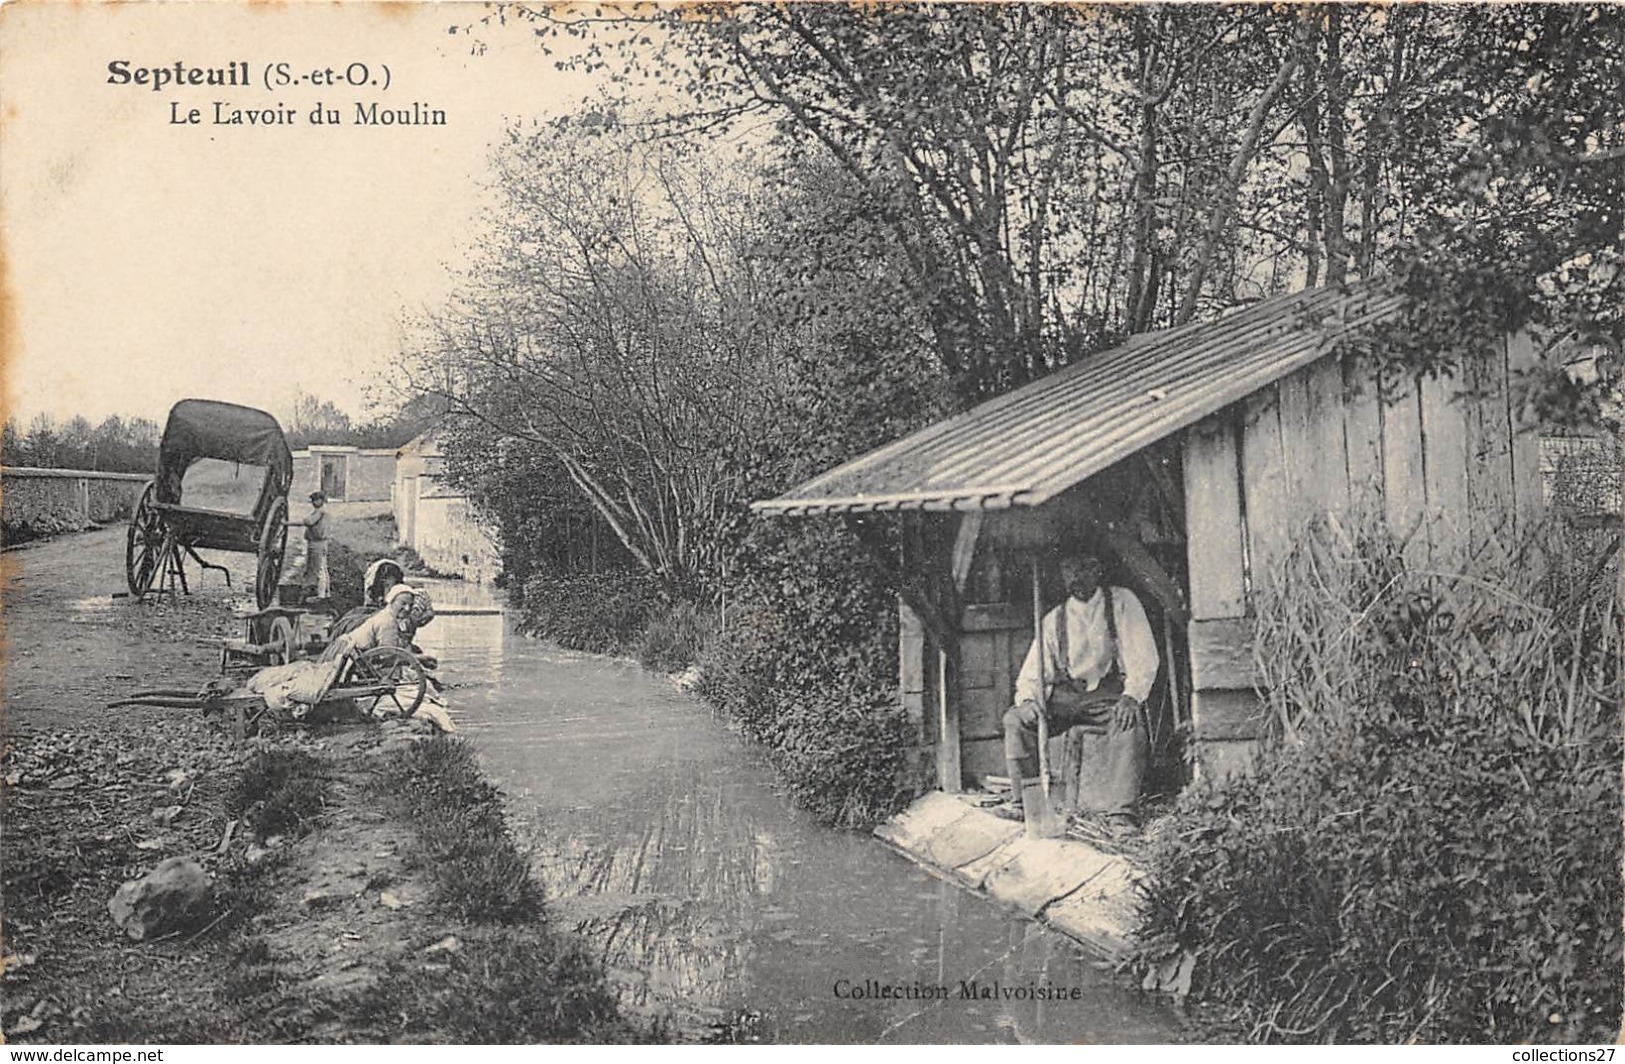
[522,572,652,655]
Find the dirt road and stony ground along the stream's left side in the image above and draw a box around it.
[0,528,626,1045]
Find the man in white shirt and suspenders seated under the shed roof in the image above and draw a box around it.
[1004,554,1160,828]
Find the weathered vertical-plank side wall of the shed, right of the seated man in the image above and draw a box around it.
[1185,336,1541,763]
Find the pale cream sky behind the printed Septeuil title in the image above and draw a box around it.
[0,3,620,424]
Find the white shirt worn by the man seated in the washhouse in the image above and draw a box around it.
[1016,588,1162,705]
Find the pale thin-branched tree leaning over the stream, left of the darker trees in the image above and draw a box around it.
[406,121,778,593]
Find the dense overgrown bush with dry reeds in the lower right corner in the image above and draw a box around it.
[1142,525,1622,1043]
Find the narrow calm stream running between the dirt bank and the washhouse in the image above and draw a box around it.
[419,583,1178,1043]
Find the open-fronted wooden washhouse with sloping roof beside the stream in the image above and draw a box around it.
[754,286,1541,807]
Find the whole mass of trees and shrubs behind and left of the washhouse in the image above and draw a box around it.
[406,5,1625,819]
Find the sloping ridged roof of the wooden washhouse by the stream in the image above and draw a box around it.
[752,288,1402,515]
